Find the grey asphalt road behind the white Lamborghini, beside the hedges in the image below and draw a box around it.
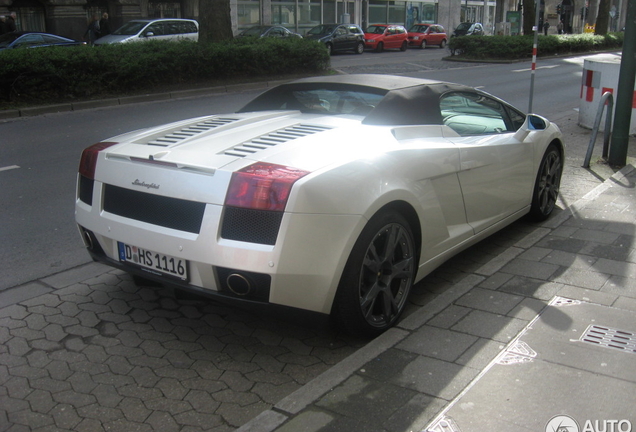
[0,48,596,291]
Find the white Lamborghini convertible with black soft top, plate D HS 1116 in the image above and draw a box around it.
[75,75,564,335]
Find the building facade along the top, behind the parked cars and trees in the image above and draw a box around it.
[0,0,628,44]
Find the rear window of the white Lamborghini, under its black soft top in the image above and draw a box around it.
[239,83,387,115]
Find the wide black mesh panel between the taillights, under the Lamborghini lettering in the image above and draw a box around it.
[104,185,205,234]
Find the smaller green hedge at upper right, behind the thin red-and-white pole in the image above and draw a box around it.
[448,33,624,60]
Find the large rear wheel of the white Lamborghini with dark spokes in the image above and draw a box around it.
[333,211,417,337]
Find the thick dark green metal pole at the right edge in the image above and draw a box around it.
[608,0,636,166]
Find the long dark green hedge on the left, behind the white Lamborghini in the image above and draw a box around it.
[0,38,330,106]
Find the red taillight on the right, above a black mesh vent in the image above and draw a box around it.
[225,162,309,211]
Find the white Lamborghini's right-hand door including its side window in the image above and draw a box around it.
[440,91,534,233]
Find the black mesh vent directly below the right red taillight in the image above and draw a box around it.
[221,207,283,245]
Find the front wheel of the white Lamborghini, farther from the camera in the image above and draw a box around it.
[530,144,563,222]
